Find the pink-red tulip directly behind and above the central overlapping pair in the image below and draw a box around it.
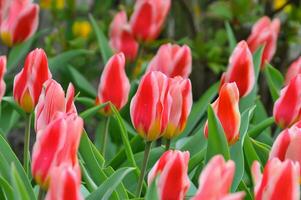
[147,44,192,78]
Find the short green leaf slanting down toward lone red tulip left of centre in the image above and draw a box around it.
[68,65,97,97]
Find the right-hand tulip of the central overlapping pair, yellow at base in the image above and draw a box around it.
[163,76,192,139]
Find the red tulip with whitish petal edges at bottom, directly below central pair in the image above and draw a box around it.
[148,150,190,200]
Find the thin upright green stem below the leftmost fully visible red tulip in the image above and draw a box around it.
[23,113,32,174]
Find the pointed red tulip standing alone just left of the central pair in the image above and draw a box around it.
[96,53,131,114]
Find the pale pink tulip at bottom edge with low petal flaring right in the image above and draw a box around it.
[193,155,245,200]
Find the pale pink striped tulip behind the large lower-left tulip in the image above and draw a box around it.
[35,79,77,132]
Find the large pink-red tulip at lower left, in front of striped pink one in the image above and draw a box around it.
[31,113,83,188]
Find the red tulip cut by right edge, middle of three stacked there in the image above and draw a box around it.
[273,75,301,128]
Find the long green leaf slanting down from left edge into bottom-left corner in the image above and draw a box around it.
[0,135,35,199]
